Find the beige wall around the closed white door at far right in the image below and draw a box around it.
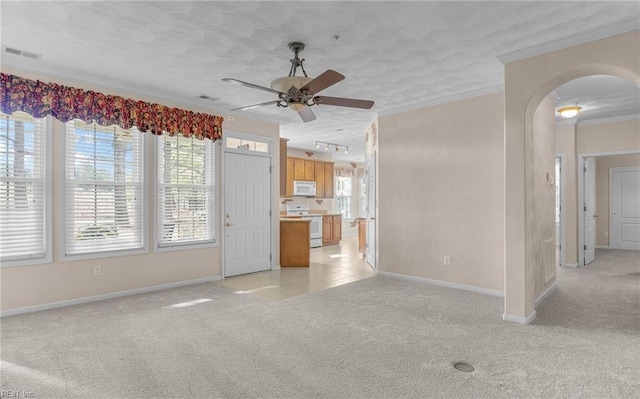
[596,153,640,247]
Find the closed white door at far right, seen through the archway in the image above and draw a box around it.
[609,168,640,250]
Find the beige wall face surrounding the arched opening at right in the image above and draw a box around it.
[503,31,640,324]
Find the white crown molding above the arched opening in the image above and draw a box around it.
[496,18,640,64]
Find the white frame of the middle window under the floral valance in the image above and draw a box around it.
[56,119,149,262]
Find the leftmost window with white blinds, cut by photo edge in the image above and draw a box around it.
[0,112,51,264]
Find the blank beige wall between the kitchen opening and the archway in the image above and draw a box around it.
[378,93,504,292]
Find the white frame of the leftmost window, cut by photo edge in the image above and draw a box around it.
[0,112,54,267]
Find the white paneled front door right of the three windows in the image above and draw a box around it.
[222,153,271,277]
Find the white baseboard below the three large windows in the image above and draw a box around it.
[0,276,222,317]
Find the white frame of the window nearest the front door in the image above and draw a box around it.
[151,133,223,252]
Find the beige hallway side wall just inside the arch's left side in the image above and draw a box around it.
[526,97,556,298]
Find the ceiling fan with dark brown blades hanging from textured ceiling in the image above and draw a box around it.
[222,42,373,122]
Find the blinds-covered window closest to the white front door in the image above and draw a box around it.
[156,135,215,247]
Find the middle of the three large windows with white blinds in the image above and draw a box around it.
[65,120,145,255]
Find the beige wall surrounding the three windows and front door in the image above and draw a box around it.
[0,68,279,312]
